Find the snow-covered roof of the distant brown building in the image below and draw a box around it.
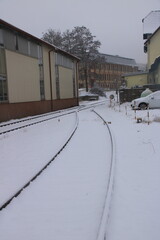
[100,53,137,66]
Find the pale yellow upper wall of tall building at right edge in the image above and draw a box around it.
[147,29,160,69]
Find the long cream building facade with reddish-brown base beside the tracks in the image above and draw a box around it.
[0,19,79,121]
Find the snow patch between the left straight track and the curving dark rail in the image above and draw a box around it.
[0,113,76,205]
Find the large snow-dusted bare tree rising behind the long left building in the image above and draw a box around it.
[42,26,101,91]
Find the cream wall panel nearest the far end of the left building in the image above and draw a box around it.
[59,66,73,99]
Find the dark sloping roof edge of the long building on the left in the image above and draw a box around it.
[0,19,80,61]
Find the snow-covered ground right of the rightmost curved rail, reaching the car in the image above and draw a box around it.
[96,100,160,240]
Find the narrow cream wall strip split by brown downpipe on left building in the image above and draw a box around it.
[43,47,56,100]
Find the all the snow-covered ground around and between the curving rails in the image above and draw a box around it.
[0,98,160,240]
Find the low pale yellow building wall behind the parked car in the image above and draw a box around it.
[125,74,147,88]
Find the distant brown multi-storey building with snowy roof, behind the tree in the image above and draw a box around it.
[79,54,138,89]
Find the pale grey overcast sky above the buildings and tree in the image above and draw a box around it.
[0,0,160,63]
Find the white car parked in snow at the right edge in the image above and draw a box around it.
[131,91,160,109]
